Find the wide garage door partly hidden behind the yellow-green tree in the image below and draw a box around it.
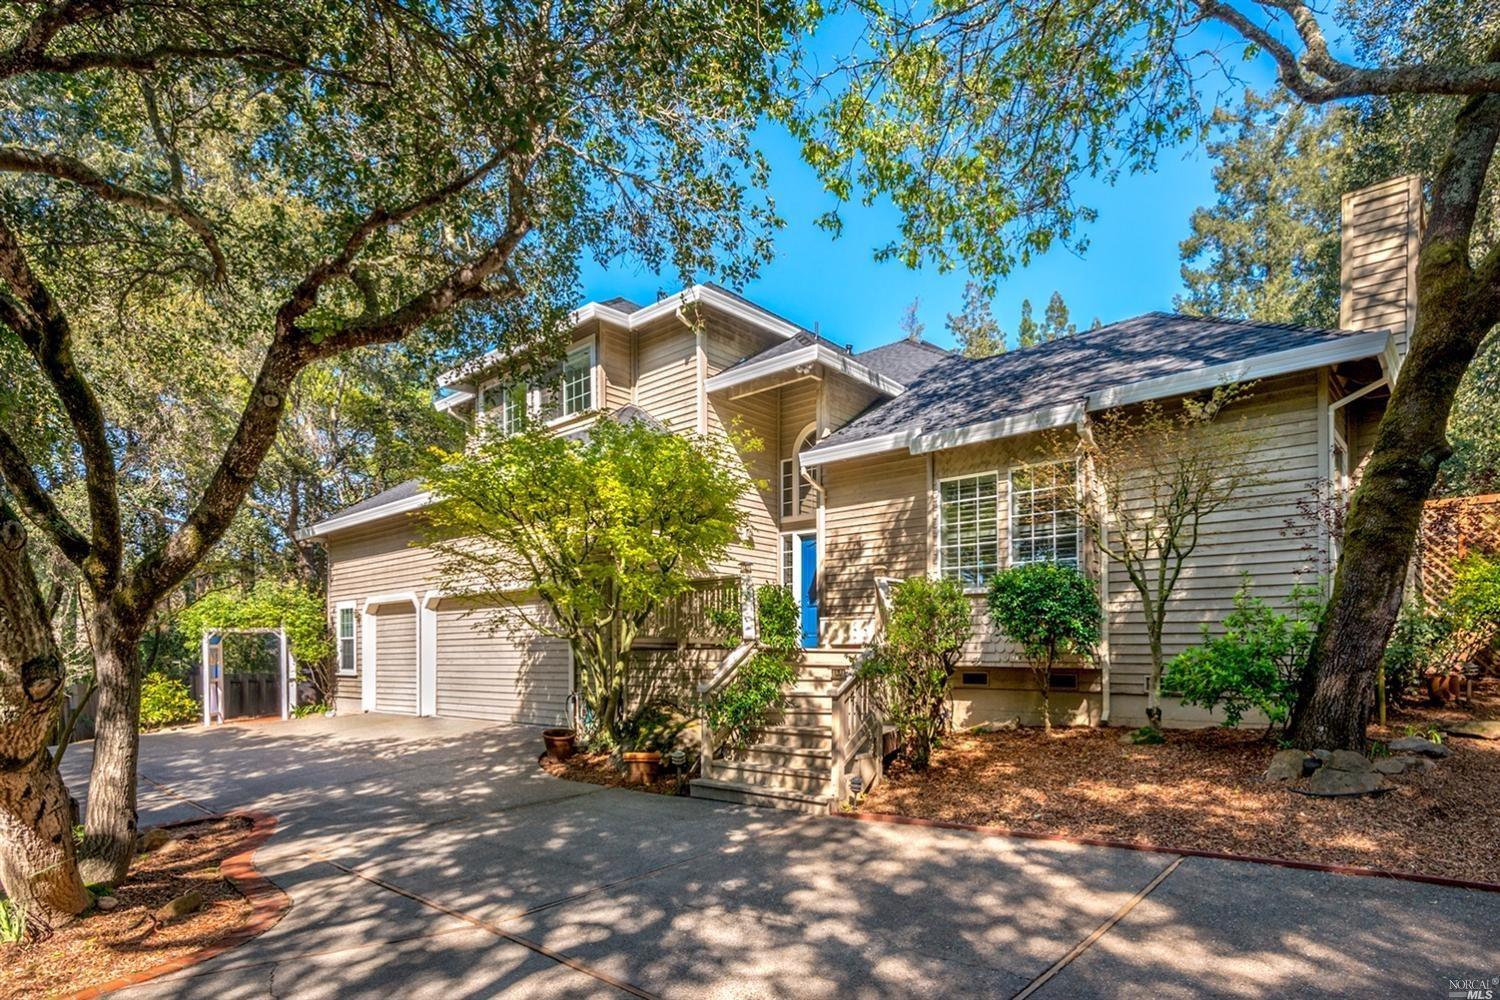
[437,601,570,726]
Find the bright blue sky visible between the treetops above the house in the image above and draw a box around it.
[582,21,1290,349]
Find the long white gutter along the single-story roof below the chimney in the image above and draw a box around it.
[801,331,1391,465]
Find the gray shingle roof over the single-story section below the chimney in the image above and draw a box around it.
[822,312,1380,447]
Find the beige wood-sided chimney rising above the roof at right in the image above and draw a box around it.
[1338,174,1424,373]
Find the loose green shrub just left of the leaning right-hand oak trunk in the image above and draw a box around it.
[1163,577,1323,736]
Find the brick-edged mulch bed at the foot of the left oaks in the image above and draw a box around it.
[0,817,254,1000]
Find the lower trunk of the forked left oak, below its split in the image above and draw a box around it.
[80,612,141,885]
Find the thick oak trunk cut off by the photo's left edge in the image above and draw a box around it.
[0,505,90,933]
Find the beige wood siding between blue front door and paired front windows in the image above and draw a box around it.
[821,451,927,646]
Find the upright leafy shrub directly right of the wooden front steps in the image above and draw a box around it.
[858,577,974,772]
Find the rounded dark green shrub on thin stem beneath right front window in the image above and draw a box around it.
[989,562,1101,733]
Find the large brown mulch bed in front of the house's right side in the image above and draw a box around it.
[860,685,1500,883]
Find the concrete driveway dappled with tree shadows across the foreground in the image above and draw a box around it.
[66,715,1500,1000]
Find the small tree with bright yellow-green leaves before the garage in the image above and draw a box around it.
[428,417,746,739]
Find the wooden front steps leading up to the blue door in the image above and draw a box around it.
[689,649,852,813]
